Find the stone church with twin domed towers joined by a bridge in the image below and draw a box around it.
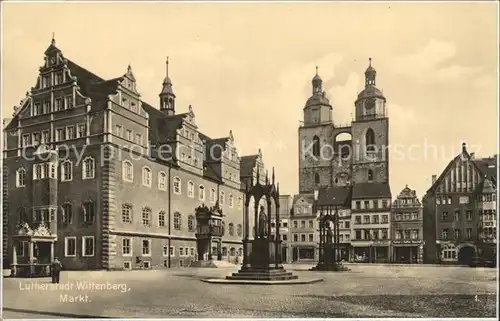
[299,58,390,194]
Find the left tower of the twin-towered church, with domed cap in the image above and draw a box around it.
[299,67,333,193]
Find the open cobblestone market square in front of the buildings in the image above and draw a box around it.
[3,265,496,318]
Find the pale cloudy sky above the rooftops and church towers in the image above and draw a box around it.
[2,3,498,197]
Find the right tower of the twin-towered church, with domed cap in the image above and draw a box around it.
[352,58,389,184]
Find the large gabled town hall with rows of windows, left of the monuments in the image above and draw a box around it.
[3,40,274,269]
